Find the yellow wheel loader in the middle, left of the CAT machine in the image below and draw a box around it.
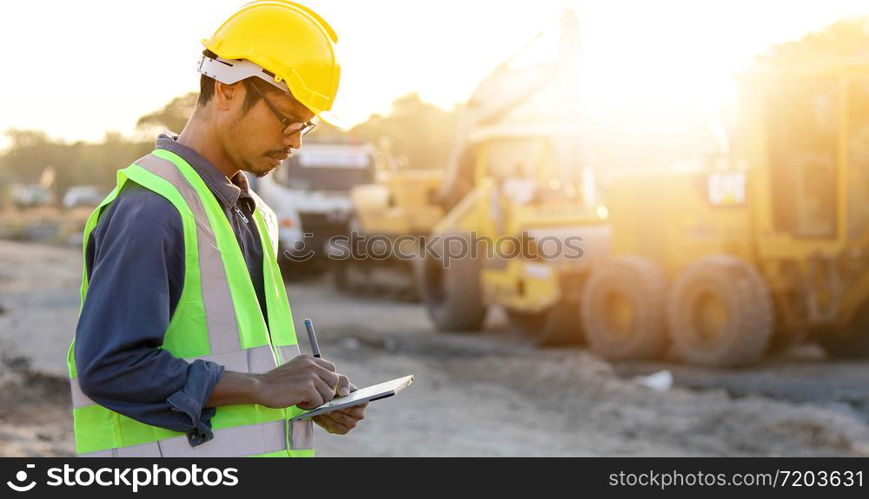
[417,126,609,345]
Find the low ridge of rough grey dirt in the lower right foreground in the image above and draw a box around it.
[438,352,869,456]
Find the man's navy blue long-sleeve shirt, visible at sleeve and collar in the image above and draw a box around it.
[75,135,266,446]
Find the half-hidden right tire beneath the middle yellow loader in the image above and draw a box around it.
[505,302,583,347]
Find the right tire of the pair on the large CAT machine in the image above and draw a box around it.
[667,255,774,367]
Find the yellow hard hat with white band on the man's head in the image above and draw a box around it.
[199,0,341,126]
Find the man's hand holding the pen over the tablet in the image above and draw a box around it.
[257,354,351,410]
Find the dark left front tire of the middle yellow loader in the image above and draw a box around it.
[414,236,488,333]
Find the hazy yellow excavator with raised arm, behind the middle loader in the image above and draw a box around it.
[340,13,596,301]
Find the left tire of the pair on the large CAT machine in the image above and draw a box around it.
[581,256,667,360]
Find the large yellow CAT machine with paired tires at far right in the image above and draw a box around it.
[581,55,869,366]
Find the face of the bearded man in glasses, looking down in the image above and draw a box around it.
[221,82,314,177]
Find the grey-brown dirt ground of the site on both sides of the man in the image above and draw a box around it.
[0,241,869,456]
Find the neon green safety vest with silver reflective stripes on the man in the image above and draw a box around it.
[67,149,314,457]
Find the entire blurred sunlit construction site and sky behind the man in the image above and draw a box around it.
[0,0,869,456]
